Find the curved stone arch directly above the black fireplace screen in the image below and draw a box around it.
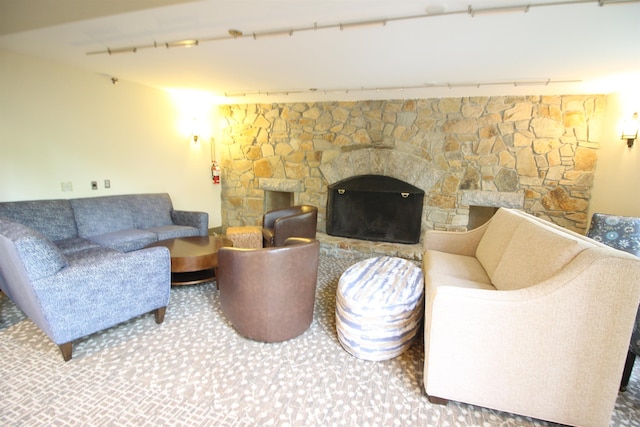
[320,148,442,193]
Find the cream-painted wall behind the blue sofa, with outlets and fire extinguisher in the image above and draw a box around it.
[0,51,221,227]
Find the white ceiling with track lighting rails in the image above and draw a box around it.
[0,0,640,103]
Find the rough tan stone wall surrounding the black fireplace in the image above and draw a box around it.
[219,95,606,237]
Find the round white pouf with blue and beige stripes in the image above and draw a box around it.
[336,257,424,361]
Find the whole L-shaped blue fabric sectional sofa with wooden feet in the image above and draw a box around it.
[0,194,208,361]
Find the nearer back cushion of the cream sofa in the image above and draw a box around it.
[491,219,590,290]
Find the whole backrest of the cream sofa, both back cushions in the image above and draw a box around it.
[476,209,596,290]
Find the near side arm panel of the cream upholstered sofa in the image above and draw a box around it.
[424,249,640,425]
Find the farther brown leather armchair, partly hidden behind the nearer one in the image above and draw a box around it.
[262,205,318,248]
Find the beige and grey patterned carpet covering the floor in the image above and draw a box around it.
[0,255,640,427]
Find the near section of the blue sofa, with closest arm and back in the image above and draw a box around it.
[0,218,171,358]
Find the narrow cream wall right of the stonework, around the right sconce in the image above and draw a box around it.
[589,89,640,222]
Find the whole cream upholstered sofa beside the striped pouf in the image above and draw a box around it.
[423,209,640,427]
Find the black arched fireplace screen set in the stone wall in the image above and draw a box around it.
[327,175,424,243]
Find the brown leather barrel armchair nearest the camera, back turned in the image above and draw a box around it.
[217,238,320,342]
